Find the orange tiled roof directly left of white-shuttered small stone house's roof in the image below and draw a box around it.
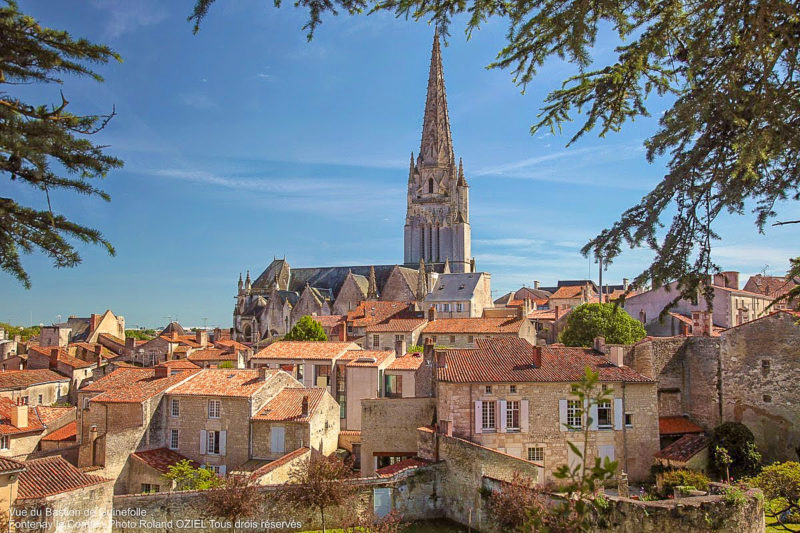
[80,368,199,403]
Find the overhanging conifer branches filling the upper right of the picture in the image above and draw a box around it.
[189,0,800,314]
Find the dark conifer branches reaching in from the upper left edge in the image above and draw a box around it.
[0,0,122,288]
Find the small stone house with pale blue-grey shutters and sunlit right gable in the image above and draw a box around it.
[251,387,339,461]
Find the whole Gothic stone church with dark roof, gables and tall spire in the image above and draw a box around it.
[233,34,482,342]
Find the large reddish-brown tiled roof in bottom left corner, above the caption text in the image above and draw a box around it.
[17,455,109,500]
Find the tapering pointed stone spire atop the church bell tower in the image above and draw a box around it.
[420,30,454,166]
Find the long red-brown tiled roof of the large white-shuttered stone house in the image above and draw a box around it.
[438,337,653,383]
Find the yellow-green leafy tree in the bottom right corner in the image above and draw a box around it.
[750,461,800,532]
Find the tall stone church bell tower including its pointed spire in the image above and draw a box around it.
[404,32,472,272]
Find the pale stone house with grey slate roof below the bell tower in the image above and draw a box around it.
[424,272,493,318]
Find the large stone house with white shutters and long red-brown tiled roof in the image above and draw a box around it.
[437,337,659,480]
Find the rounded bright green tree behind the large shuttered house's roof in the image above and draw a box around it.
[559,303,647,346]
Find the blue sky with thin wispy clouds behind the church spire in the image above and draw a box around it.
[0,0,800,327]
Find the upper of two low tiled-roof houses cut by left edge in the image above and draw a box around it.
[0,368,70,406]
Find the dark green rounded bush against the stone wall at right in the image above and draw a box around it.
[709,422,761,479]
